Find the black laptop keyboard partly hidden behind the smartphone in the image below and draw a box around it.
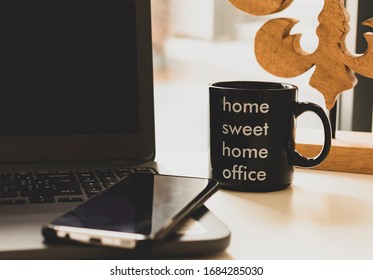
[0,167,157,205]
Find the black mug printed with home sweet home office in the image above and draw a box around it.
[209,81,332,192]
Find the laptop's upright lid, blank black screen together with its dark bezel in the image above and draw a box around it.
[0,0,155,163]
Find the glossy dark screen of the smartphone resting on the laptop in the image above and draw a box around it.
[52,174,217,240]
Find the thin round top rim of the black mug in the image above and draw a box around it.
[210,80,298,91]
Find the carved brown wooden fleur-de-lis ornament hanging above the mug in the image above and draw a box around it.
[229,0,373,109]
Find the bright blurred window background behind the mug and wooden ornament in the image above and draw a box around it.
[152,0,373,153]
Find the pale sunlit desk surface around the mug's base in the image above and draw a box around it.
[157,150,373,260]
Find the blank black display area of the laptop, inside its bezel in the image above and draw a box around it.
[0,0,139,136]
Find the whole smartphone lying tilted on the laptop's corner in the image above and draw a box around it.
[42,173,219,249]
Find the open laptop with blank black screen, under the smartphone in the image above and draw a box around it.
[0,0,229,259]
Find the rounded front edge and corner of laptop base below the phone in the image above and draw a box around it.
[0,206,230,260]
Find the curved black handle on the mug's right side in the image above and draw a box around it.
[293,102,332,167]
